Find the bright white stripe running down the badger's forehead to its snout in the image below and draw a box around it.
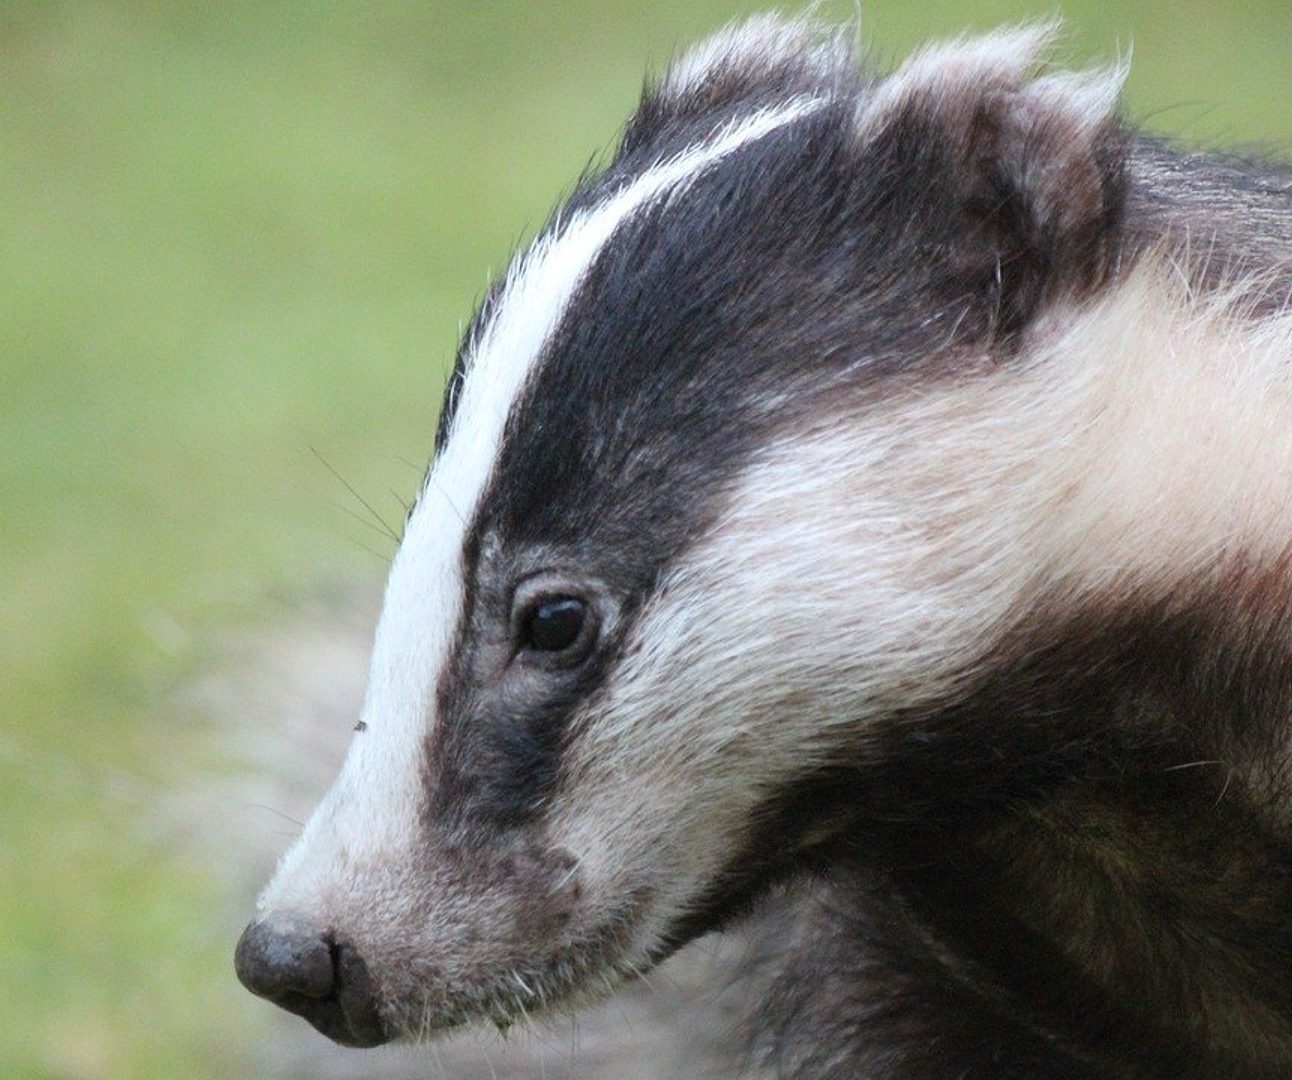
[261,90,823,908]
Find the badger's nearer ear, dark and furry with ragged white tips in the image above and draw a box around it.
[858,22,1127,337]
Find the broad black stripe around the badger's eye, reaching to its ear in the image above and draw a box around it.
[418,78,1126,822]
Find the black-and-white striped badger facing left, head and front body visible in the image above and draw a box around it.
[235,17,1292,1080]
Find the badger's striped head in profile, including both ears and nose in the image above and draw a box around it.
[238,19,1120,1045]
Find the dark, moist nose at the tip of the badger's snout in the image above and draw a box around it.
[234,916,390,1046]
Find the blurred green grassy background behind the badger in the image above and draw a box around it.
[0,0,1292,1077]
